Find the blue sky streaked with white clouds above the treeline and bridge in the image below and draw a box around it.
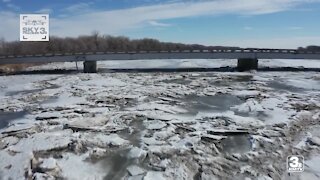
[0,0,320,48]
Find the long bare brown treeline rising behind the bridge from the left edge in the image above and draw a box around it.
[0,33,238,56]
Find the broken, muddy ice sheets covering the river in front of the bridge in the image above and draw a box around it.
[0,72,320,180]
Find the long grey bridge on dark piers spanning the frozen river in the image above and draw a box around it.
[0,48,320,73]
